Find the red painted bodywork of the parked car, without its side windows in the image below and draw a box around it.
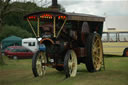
[5,46,34,58]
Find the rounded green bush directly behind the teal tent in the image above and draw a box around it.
[0,25,32,40]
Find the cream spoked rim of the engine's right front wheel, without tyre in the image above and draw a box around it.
[68,51,77,77]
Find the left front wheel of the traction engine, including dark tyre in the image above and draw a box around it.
[32,51,47,77]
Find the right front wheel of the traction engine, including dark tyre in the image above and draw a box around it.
[64,50,77,78]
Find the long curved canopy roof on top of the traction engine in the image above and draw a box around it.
[24,11,105,22]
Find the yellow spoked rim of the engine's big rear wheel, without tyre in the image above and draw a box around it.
[92,36,103,71]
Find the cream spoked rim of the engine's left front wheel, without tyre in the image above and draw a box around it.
[36,52,46,76]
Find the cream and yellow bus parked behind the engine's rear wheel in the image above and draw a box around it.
[102,30,128,56]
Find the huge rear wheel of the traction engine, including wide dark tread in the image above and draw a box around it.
[86,33,103,72]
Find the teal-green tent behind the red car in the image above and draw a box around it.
[1,36,22,50]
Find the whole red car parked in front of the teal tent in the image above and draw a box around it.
[5,46,34,59]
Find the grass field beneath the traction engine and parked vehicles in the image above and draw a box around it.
[0,57,128,85]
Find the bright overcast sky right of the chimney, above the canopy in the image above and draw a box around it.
[58,0,128,16]
